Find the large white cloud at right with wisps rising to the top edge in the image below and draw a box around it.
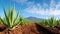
[24,0,60,16]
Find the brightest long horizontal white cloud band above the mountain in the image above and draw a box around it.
[24,7,60,16]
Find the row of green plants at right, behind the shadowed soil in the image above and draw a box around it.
[39,17,60,27]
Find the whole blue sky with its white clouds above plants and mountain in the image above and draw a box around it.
[0,0,60,19]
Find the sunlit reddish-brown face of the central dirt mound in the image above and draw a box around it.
[10,24,43,34]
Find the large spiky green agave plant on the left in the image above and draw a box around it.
[0,7,22,29]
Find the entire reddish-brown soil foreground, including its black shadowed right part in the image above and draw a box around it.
[0,23,60,34]
